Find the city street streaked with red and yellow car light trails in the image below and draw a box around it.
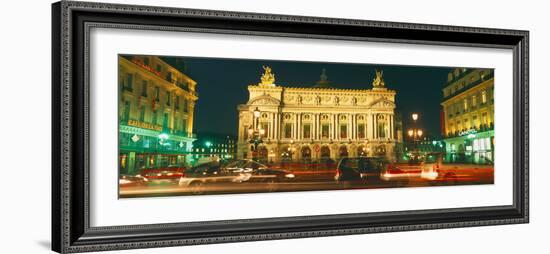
[120,164,493,198]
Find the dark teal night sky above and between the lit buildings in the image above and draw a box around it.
[162,57,453,138]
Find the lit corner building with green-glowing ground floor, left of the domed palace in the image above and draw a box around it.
[118,55,198,174]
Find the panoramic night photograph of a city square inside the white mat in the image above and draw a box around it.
[118,54,495,198]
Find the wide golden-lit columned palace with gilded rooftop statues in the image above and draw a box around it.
[237,66,396,162]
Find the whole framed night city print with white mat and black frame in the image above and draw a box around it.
[52,1,529,253]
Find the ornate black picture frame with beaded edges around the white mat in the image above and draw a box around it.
[52,1,529,253]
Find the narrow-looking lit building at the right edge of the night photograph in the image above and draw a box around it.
[441,68,495,163]
